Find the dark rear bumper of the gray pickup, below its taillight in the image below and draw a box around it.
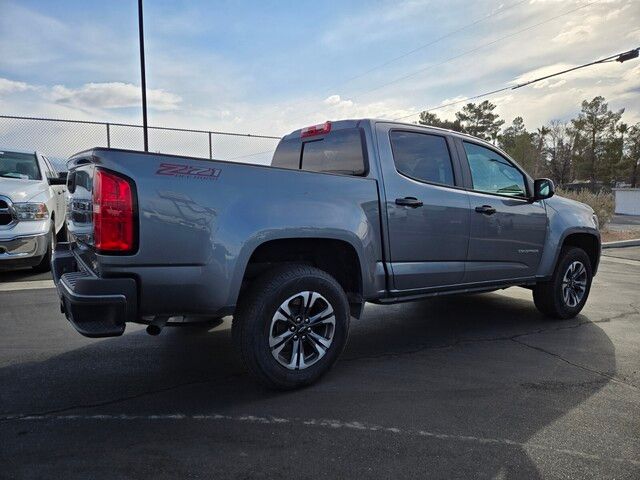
[51,243,138,338]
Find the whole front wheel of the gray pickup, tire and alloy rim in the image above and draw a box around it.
[533,247,593,319]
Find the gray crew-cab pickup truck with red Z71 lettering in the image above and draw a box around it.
[53,120,600,389]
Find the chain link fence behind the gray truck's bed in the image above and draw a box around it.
[0,115,280,168]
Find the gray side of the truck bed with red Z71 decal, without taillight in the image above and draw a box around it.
[69,148,384,315]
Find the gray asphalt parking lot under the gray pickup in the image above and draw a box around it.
[0,247,640,479]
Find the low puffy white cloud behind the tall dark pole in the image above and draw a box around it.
[49,82,181,110]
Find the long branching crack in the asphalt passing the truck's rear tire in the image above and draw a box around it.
[0,304,640,423]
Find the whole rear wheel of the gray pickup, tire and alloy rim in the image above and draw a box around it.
[232,265,350,389]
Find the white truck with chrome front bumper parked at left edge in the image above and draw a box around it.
[0,149,66,271]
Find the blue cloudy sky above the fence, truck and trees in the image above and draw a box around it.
[0,0,640,141]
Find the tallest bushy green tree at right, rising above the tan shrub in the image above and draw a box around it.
[571,96,624,182]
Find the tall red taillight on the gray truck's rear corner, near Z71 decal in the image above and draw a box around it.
[93,170,135,253]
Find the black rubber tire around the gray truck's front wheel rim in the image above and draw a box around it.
[533,247,593,319]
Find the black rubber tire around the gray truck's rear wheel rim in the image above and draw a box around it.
[232,265,350,390]
